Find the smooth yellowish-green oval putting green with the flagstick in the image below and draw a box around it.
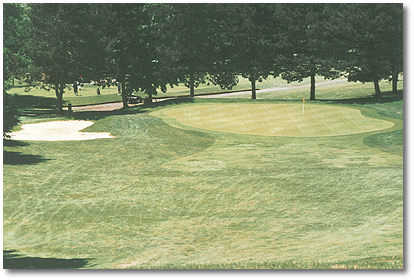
[151,104,394,137]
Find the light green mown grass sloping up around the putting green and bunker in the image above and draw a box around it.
[4,81,403,269]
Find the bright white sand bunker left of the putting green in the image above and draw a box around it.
[10,121,114,141]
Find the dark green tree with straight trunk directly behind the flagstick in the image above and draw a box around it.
[282,4,340,100]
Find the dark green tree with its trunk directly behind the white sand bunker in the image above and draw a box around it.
[30,4,105,113]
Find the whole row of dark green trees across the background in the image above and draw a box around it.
[3,3,403,112]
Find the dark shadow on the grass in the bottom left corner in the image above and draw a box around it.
[3,250,90,269]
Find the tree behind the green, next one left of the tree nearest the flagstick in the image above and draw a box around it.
[213,4,286,99]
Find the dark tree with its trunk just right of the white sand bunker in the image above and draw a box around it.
[96,4,177,109]
